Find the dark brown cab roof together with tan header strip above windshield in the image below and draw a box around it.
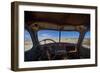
[25,11,90,30]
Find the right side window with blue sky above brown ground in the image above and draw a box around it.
[82,31,90,48]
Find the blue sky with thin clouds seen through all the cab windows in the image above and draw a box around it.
[24,30,90,40]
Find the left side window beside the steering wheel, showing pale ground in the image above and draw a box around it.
[24,29,33,51]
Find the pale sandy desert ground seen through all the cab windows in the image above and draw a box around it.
[24,38,90,51]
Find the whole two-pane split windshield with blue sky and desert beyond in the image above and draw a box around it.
[38,30,79,44]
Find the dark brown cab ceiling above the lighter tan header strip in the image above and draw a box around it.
[25,11,90,28]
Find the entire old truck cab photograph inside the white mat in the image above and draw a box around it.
[24,11,90,61]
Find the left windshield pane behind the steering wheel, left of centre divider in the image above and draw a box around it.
[38,30,59,44]
